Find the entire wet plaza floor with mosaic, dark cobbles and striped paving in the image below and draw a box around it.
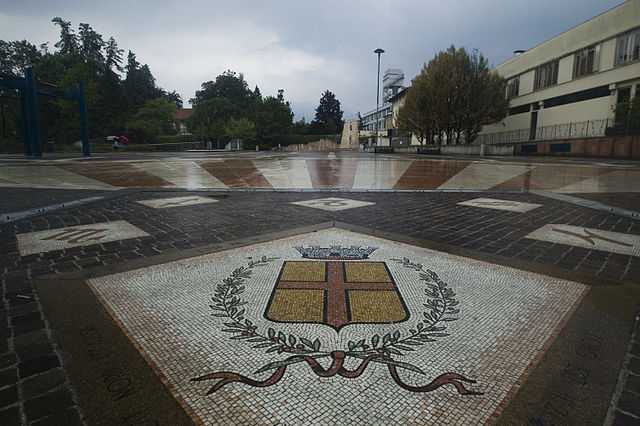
[0,152,640,425]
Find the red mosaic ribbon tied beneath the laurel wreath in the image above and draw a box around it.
[191,351,482,395]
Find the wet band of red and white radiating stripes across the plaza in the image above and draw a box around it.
[0,154,640,194]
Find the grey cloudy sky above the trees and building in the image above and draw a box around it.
[0,0,621,119]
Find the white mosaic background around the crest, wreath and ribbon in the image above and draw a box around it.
[89,229,586,425]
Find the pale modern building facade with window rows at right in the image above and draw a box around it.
[475,0,640,143]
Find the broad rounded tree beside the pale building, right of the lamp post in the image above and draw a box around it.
[398,46,508,144]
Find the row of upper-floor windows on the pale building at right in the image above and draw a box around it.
[507,29,640,99]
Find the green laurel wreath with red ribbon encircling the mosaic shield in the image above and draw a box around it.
[191,247,482,395]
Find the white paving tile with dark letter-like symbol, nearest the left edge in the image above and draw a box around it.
[16,220,149,256]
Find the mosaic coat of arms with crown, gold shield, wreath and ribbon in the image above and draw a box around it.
[192,246,482,395]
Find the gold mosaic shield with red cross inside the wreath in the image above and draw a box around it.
[265,261,409,330]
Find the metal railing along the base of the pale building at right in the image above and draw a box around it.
[474,118,614,144]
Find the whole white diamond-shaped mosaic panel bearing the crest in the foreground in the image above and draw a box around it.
[89,229,585,425]
